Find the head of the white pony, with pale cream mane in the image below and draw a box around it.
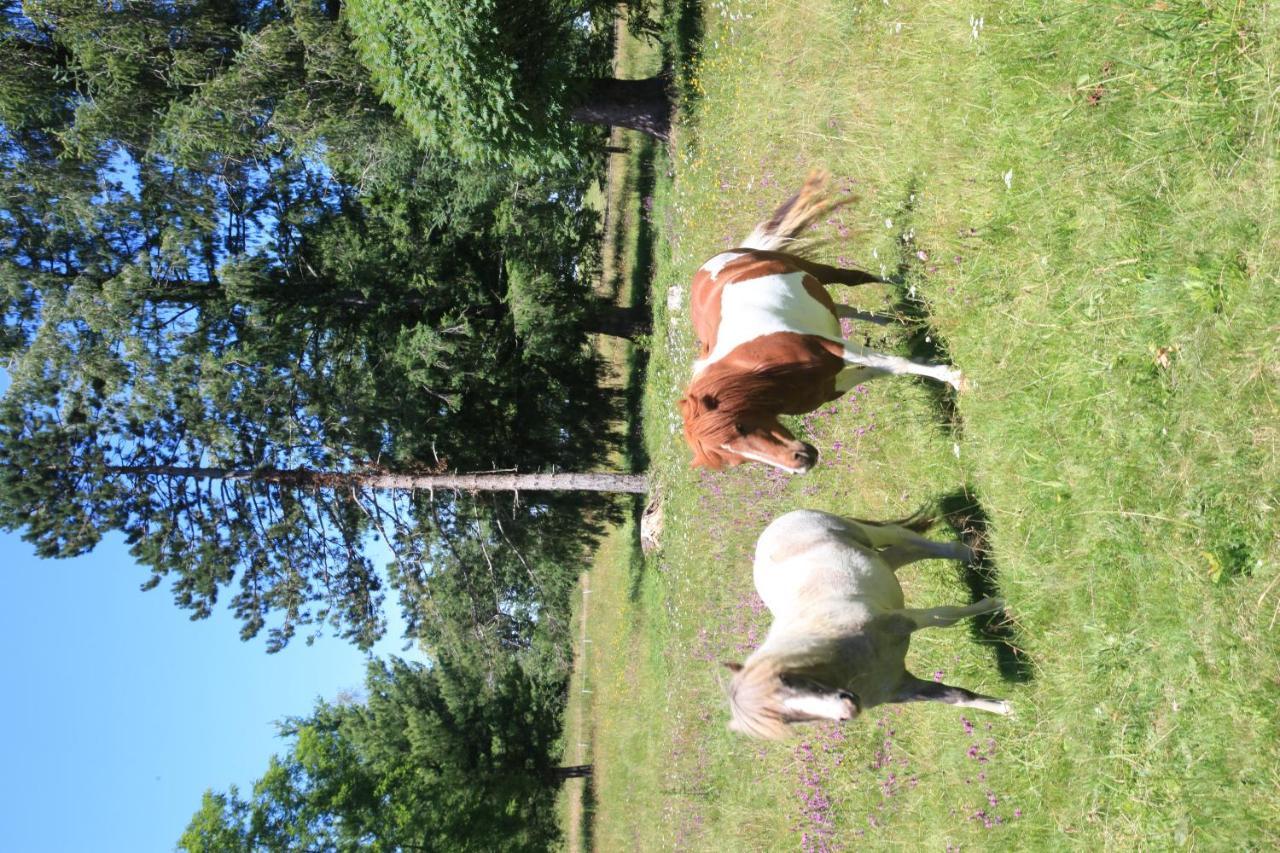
[724,660,861,740]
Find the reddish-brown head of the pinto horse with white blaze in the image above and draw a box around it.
[680,392,818,474]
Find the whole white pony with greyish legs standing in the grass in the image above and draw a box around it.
[727,510,1010,739]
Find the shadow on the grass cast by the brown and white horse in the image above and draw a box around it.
[888,178,964,438]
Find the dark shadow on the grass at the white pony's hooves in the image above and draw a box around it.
[938,489,1033,681]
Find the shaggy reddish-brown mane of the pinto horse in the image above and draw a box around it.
[678,365,795,470]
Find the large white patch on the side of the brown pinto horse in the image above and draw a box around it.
[694,272,844,377]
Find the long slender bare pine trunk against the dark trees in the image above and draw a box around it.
[106,465,649,494]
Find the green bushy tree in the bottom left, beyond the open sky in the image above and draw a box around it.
[178,660,589,853]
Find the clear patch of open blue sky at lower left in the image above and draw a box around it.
[0,522,421,853]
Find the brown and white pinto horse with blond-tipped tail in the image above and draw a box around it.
[680,172,963,474]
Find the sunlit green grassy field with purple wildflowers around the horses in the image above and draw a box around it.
[576,0,1280,852]
